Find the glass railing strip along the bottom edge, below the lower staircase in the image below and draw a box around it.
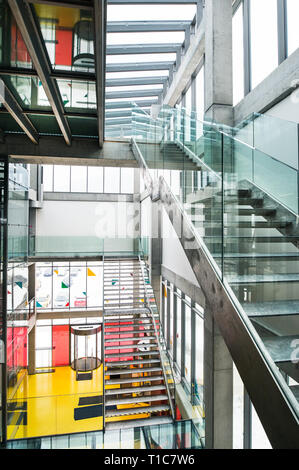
[7,420,203,450]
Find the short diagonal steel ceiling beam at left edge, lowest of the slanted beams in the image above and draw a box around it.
[0,79,38,144]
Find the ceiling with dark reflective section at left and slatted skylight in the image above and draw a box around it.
[0,0,202,147]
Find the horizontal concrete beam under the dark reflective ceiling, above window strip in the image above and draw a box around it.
[0,134,137,168]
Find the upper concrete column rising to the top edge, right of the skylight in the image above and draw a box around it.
[205,0,233,125]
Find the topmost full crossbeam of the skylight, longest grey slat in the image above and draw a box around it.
[107,21,191,33]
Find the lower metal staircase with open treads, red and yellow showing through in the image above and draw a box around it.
[103,258,173,429]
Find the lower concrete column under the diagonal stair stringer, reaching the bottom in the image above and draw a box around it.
[204,306,233,449]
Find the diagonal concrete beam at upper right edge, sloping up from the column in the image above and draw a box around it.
[234,49,299,125]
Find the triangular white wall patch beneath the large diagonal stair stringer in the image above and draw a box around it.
[162,208,199,286]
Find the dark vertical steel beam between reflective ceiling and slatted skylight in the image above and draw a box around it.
[94,0,107,148]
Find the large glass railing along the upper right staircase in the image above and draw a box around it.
[132,107,299,428]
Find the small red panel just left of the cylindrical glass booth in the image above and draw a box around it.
[52,325,70,366]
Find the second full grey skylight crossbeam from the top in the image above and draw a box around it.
[106,43,182,55]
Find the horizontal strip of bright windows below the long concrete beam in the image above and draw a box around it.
[43,165,134,194]
